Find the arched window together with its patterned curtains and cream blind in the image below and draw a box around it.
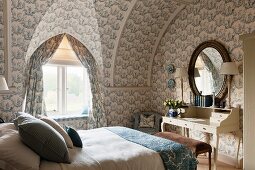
[24,34,107,128]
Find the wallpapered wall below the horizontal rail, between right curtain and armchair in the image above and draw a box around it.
[105,88,152,127]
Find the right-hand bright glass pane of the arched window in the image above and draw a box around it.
[66,67,90,114]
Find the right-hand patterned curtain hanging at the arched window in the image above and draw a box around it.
[66,35,107,128]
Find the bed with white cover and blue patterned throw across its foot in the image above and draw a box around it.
[0,115,197,170]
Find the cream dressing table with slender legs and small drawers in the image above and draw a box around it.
[161,106,240,169]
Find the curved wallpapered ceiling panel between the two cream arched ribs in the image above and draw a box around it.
[112,0,190,87]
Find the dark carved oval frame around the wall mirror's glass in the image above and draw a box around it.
[188,40,231,103]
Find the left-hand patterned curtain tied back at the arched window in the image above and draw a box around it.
[25,34,64,116]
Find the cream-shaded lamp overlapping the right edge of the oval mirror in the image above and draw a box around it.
[220,62,238,108]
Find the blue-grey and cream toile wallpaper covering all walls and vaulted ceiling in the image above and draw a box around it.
[0,0,255,161]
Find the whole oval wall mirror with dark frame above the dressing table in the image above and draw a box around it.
[188,41,230,101]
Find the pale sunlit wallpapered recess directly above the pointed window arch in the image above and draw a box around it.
[27,0,102,65]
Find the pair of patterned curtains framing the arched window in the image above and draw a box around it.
[25,33,106,128]
